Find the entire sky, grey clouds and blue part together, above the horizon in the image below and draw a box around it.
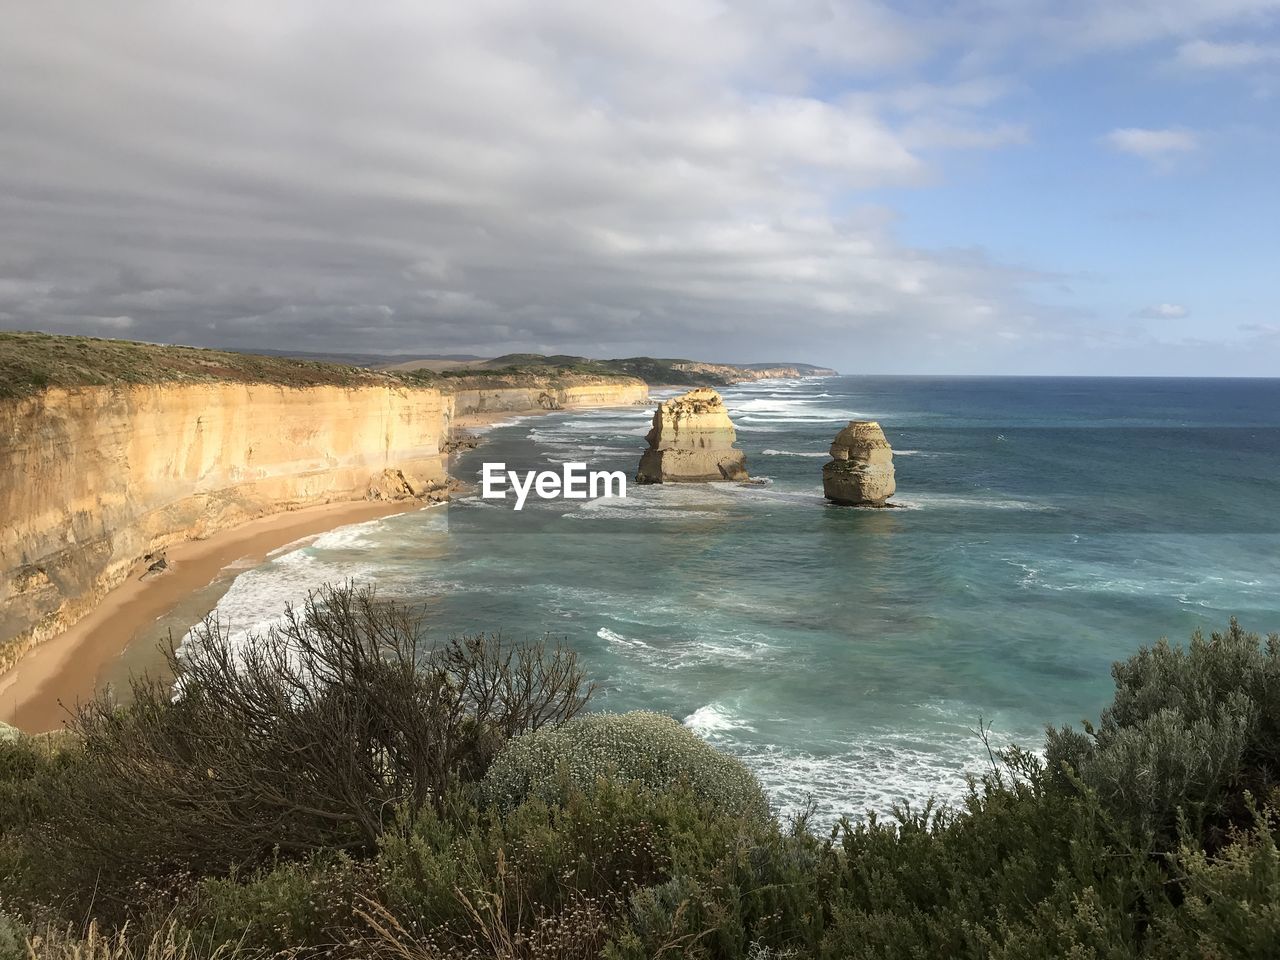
[0,0,1280,376]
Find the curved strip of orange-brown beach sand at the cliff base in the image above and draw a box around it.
[0,500,421,733]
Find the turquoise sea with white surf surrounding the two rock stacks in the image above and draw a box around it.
[194,378,1280,817]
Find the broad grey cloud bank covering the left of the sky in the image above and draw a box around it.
[0,0,1269,362]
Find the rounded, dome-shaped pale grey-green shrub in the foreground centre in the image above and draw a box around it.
[483,710,769,819]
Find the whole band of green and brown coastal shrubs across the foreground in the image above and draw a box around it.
[0,588,1280,960]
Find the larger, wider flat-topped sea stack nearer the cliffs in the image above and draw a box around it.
[636,387,746,484]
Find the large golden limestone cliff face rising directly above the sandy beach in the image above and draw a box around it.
[0,383,453,669]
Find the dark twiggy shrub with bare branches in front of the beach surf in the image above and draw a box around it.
[26,586,591,915]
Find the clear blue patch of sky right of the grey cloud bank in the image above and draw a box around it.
[882,34,1280,375]
